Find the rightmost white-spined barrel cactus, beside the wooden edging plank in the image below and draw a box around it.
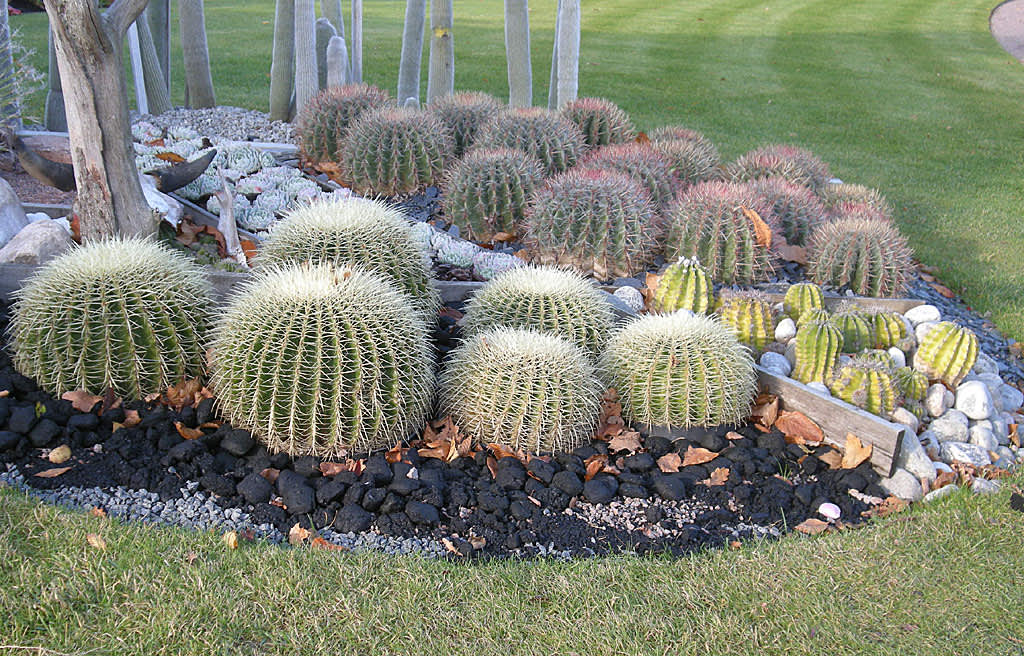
[603,312,756,428]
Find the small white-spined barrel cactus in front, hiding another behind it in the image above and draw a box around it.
[440,327,604,453]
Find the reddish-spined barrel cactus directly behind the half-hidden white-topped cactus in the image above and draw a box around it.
[523,169,659,280]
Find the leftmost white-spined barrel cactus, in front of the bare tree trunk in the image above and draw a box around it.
[10,237,212,399]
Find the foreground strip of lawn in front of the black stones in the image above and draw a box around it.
[0,478,1024,656]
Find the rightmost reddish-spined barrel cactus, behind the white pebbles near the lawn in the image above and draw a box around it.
[808,214,912,297]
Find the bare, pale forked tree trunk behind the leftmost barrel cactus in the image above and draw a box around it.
[45,0,158,239]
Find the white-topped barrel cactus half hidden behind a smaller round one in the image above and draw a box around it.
[463,267,613,355]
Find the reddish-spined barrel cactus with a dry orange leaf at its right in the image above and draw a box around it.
[665,181,771,285]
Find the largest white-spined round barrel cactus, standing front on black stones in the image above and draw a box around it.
[211,264,434,457]
